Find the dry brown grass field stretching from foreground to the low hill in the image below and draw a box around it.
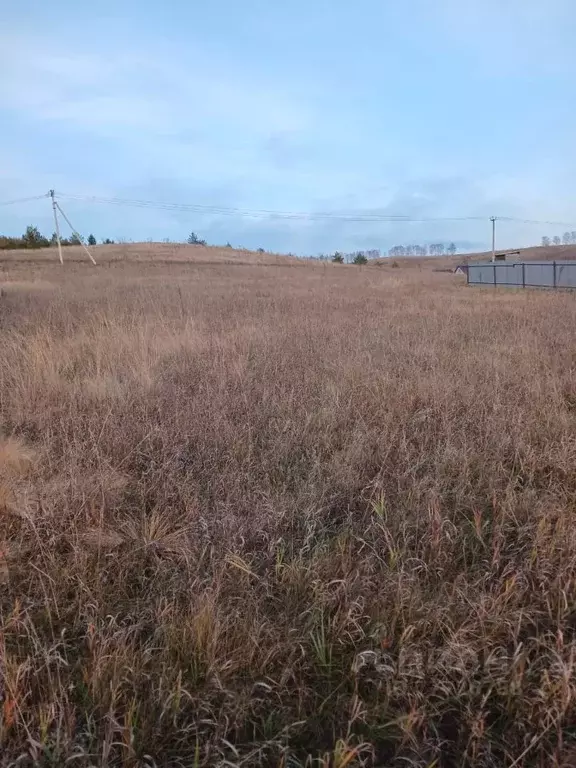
[0,246,576,768]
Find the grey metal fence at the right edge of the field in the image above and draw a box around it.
[466,261,576,288]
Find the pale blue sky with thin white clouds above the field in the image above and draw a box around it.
[0,0,576,255]
